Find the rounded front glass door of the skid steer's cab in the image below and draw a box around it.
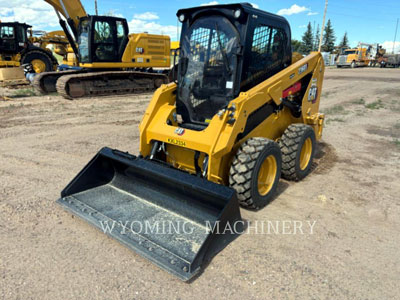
[177,16,238,123]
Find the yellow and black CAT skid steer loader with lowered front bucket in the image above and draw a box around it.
[58,4,324,280]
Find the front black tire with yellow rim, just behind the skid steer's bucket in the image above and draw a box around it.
[229,138,282,209]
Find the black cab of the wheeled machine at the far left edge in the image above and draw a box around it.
[0,22,32,54]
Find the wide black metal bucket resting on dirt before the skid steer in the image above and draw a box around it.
[58,148,242,281]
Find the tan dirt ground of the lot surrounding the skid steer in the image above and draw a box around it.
[0,68,400,299]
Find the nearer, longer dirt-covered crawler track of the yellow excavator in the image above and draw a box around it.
[56,71,169,100]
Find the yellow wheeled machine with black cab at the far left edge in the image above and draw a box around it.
[0,22,63,86]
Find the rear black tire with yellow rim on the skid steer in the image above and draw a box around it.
[279,124,316,181]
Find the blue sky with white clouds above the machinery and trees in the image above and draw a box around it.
[0,0,400,50]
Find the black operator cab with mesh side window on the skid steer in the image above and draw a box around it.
[176,3,292,130]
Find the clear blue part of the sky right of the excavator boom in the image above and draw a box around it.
[83,0,400,48]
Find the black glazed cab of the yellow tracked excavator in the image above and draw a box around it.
[77,16,129,63]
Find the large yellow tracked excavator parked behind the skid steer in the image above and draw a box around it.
[33,0,170,99]
